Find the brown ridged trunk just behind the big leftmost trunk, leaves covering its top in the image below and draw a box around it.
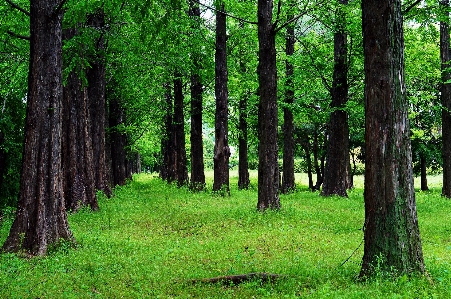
[62,54,99,211]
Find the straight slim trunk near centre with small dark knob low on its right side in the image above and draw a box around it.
[213,2,230,193]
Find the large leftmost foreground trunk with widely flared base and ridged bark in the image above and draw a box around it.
[3,0,73,255]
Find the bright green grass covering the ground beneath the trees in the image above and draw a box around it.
[0,172,451,298]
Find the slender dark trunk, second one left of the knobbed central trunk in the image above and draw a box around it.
[172,73,188,187]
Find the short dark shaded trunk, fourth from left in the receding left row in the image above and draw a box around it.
[109,97,131,186]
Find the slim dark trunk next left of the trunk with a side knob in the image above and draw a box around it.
[189,1,205,190]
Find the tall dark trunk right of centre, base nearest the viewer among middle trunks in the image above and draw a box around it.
[257,0,280,211]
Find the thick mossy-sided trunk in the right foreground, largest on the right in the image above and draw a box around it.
[360,0,424,277]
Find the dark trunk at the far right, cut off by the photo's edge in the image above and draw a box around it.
[440,0,451,198]
